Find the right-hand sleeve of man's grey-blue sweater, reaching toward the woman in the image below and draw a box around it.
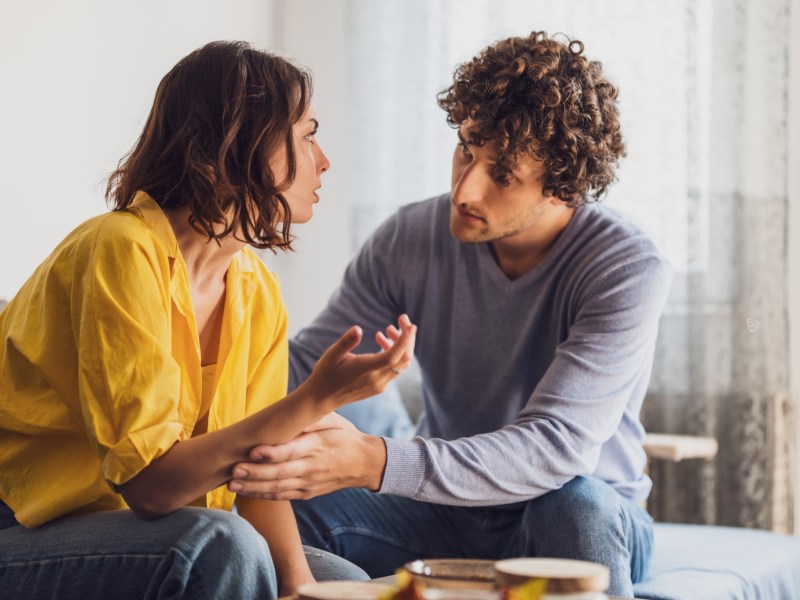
[380,253,671,506]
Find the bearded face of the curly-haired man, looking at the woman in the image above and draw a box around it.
[450,120,554,243]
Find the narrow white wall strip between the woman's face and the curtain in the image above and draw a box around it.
[263,0,358,334]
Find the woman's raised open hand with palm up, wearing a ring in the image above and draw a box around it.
[302,315,417,410]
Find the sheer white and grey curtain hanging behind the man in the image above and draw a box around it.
[338,0,795,530]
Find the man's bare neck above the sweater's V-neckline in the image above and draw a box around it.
[489,205,575,281]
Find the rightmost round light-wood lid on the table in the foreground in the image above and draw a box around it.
[494,558,610,594]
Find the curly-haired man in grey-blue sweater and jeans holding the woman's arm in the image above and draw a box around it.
[230,32,671,596]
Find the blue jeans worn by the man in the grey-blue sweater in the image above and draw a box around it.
[293,477,653,596]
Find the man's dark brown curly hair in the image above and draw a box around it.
[438,31,625,207]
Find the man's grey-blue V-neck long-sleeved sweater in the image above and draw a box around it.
[290,195,671,506]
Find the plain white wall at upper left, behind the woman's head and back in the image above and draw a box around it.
[0,0,273,298]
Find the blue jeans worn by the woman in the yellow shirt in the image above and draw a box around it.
[0,502,366,600]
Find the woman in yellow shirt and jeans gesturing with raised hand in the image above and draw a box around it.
[0,42,415,598]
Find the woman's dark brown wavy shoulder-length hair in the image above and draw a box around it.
[106,42,312,249]
